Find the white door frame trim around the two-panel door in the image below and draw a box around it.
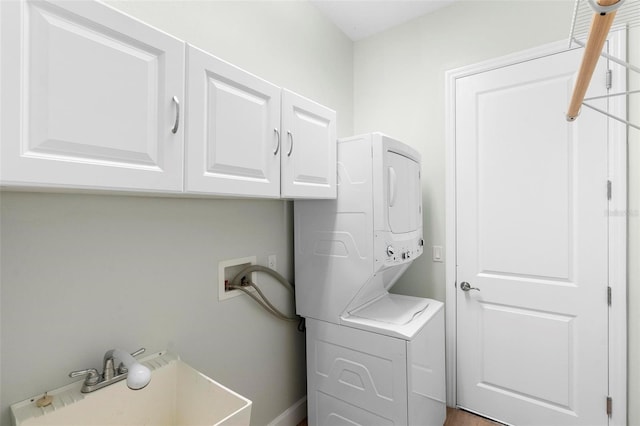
[445,30,627,426]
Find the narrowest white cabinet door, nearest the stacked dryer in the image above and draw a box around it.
[281,90,337,198]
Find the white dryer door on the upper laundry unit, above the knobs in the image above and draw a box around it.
[385,150,422,234]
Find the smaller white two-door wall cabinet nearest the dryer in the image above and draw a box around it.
[185,46,337,198]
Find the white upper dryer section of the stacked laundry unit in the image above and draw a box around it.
[294,133,423,324]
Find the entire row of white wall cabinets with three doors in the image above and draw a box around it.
[0,0,337,198]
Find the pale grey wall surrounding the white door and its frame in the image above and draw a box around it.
[354,0,640,426]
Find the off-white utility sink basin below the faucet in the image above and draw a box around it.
[11,352,251,426]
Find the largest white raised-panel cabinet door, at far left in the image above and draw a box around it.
[0,1,184,191]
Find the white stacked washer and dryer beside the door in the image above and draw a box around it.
[294,133,446,426]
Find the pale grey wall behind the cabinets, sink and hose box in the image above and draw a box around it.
[0,1,353,425]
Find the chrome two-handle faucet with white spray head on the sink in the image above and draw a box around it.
[69,348,151,393]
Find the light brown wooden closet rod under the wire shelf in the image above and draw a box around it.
[567,0,620,121]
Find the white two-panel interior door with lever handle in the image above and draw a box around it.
[456,50,608,426]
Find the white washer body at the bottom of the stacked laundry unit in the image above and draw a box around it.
[307,296,446,426]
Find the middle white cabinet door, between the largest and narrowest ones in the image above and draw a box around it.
[186,46,280,198]
